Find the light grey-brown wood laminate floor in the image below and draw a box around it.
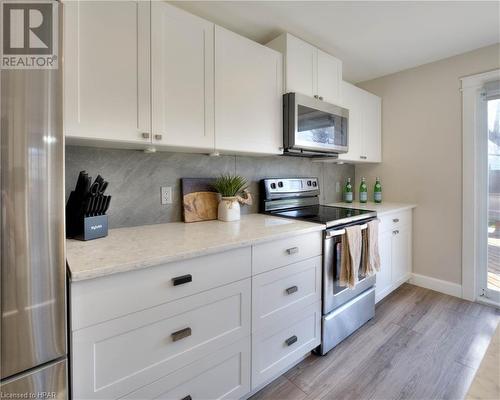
[252,284,500,400]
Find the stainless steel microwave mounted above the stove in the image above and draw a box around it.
[283,93,349,157]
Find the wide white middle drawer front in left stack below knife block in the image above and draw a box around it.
[72,279,251,399]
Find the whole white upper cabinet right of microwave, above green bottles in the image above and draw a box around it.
[339,82,382,163]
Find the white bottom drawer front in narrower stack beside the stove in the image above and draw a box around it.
[252,302,321,389]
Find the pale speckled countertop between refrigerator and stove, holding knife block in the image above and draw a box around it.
[66,214,325,281]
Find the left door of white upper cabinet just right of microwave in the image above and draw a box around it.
[339,82,363,162]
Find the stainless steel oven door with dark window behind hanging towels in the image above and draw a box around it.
[323,223,376,315]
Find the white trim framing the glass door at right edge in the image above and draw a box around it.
[461,69,500,301]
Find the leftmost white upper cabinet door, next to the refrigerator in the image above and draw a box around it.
[63,1,150,142]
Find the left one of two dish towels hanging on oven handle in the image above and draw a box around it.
[339,225,362,289]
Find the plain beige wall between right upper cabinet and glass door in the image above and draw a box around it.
[356,44,500,284]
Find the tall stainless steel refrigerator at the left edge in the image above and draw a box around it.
[0,2,68,399]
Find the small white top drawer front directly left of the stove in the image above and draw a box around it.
[252,232,323,275]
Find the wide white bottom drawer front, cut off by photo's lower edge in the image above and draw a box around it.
[123,337,250,400]
